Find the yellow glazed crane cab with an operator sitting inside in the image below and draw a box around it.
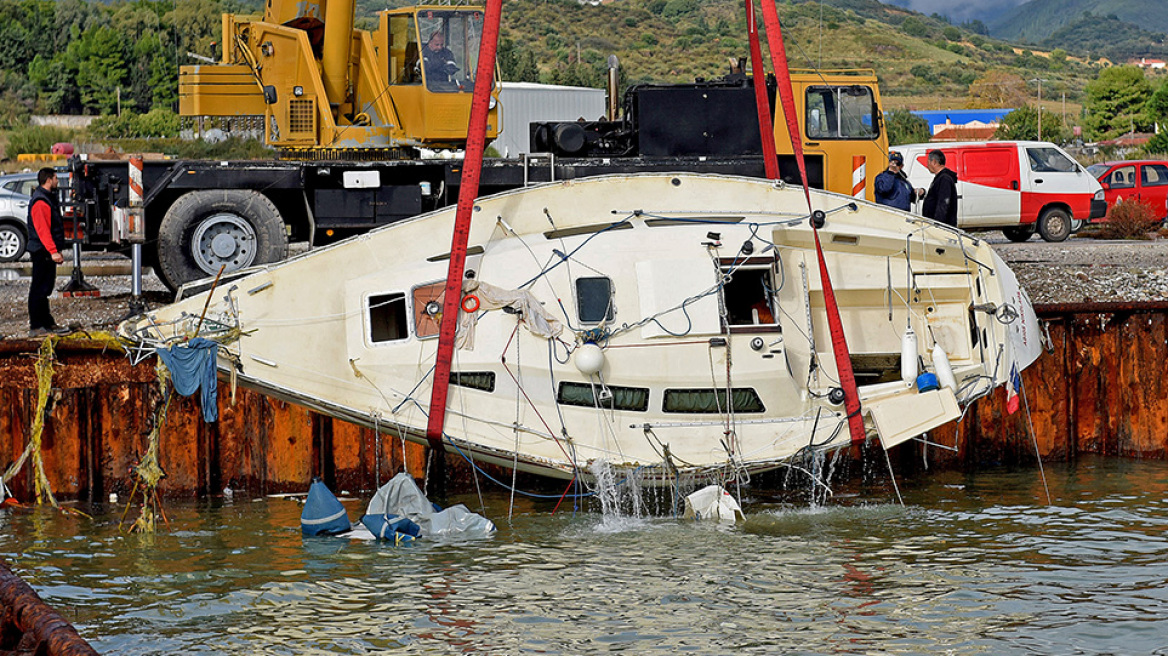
[376,6,499,147]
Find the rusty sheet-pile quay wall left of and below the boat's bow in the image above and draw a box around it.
[0,341,425,501]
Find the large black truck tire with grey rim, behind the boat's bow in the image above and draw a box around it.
[158,189,287,289]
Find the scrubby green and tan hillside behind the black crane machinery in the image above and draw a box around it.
[492,0,1111,109]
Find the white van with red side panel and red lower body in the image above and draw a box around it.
[892,141,1107,242]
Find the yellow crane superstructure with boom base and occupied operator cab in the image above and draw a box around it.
[179,0,499,160]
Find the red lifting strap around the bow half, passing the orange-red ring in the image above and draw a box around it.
[426,0,502,448]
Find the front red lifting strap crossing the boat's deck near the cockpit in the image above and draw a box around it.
[746,0,867,444]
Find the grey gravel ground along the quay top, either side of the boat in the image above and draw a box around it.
[0,231,1168,339]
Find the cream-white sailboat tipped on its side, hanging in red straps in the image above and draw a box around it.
[120,174,1041,483]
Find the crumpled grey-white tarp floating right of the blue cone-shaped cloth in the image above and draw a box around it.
[366,472,495,538]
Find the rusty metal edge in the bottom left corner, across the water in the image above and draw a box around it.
[0,560,97,656]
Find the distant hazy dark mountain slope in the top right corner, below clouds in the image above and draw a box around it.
[986,0,1168,42]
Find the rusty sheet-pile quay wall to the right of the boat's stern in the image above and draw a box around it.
[902,302,1168,468]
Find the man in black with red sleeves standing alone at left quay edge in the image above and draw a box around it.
[28,167,69,337]
